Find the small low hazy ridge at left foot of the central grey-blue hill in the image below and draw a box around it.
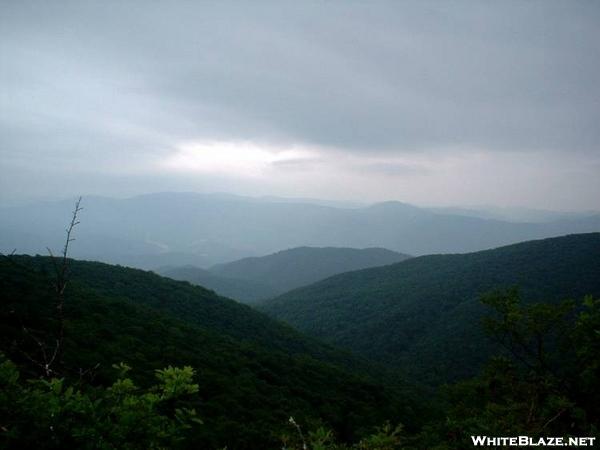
[154,266,280,303]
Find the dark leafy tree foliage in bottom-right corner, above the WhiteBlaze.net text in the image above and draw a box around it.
[421,289,600,449]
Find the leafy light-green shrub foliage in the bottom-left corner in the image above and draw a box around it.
[0,358,202,449]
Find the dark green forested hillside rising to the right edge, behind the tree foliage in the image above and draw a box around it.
[260,233,600,382]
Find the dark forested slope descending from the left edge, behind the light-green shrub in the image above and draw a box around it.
[0,256,415,449]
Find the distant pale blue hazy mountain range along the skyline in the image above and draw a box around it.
[0,193,600,269]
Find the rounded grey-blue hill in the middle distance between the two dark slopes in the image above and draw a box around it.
[210,247,409,298]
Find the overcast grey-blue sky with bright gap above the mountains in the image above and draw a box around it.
[0,0,600,210]
